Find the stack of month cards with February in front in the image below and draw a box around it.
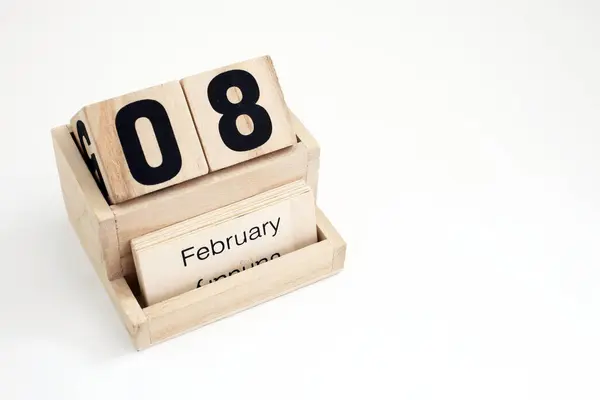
[131,181,317,305]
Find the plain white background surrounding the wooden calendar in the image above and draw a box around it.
[0,0,600,400]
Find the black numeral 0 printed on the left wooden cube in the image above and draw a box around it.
[115,100,182,185]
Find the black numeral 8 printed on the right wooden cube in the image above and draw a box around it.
[207,69,273,151]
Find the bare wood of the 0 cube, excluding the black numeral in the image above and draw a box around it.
[71,81,208,204]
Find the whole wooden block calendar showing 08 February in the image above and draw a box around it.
[52,57,346,350]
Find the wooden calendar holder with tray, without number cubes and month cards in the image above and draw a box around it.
[52,111,346,350]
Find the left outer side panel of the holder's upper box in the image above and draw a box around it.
[52,125,121,279]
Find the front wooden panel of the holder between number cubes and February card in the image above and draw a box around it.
[111,139,308,275]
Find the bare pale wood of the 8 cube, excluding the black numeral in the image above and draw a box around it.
[181,56,296,171]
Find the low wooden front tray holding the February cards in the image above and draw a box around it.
[108,211,346,350]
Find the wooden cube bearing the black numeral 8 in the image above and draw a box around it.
[181,56,296,171]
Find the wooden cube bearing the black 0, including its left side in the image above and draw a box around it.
[71,81,208,204]
